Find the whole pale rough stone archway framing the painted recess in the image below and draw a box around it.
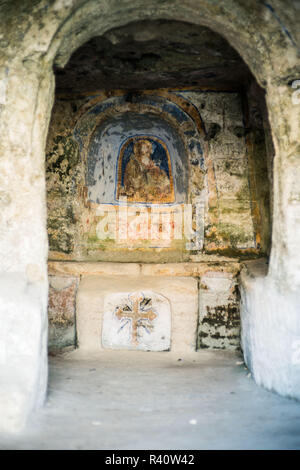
[0,0,300,430]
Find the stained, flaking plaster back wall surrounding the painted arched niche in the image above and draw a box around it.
[46,92,270,262]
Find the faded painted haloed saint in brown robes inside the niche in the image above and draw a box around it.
[119,139,172,203]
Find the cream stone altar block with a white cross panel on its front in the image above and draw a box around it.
[77,276,198,352]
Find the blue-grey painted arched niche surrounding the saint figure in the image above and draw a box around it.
[86,112,188,204]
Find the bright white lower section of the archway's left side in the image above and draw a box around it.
[0,273,47,432]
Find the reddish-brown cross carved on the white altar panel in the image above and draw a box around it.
[115,292,157,345]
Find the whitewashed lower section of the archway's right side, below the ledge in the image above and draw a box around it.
[240,261,300,399]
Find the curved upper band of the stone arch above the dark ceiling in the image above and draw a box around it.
[45,0,295,85]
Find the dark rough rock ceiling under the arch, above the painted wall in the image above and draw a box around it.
[54,20,251,93]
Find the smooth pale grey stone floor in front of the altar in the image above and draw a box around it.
[0,350,300,450]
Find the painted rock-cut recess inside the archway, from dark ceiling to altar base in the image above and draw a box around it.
[46,20,274,351]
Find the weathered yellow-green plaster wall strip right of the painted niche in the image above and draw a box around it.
[177,91,265,254]
